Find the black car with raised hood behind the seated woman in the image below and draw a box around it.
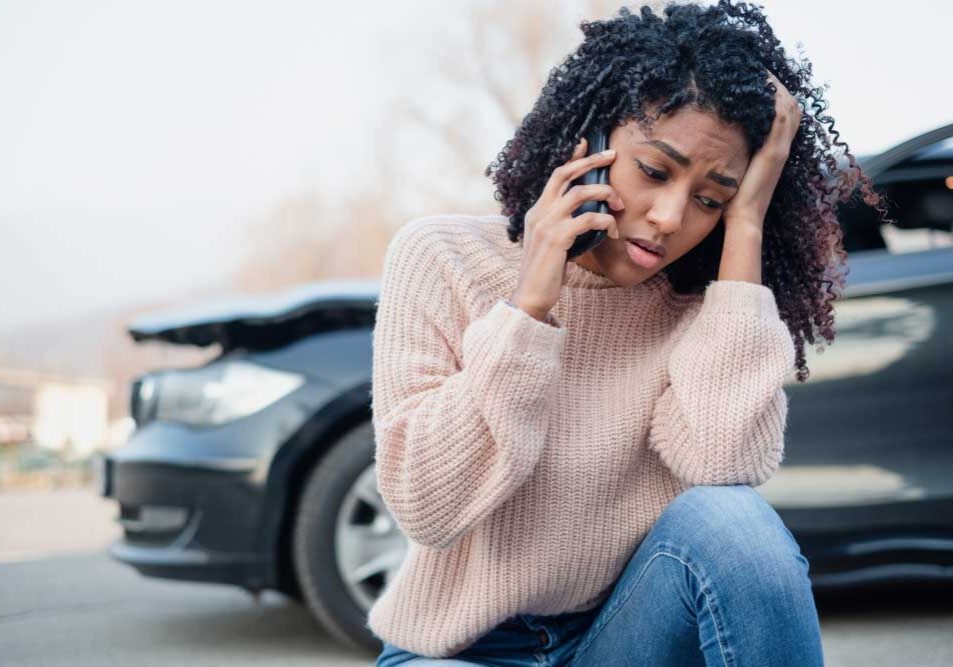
[100,125,953,651]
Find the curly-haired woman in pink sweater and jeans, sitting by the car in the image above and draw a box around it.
[368,0,883,667]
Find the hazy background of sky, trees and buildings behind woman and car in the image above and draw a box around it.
[0,0,953,664]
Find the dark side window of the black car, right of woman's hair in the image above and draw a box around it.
[838,137,953,254]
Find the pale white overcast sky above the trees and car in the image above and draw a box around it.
[0,0,953,330]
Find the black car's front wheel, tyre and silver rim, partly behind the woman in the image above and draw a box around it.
[292,422,407,651]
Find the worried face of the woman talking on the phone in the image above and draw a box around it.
[574,106,749,286]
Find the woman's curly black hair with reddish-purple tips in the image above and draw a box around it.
[485,0,888,382]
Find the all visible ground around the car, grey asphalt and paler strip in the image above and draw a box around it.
[0,490,953,667]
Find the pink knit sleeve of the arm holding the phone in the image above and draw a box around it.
[371,219,566,549]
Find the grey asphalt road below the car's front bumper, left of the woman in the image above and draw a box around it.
[0,552,374,667]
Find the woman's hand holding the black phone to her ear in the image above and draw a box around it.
[510,139,624,321]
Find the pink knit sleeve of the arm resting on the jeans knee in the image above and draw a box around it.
[649,280,794,486]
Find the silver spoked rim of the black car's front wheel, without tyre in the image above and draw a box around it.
[334,464,407,612]
